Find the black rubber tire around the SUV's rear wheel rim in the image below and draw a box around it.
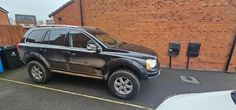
[27,61,52,83]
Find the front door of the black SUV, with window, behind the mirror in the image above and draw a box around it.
[68,31,105,75]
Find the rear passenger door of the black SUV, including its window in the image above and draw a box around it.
[40,29,69,71]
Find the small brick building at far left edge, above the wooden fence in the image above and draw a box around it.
[0,7,10,25]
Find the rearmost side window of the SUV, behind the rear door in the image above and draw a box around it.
[26,30,47,43]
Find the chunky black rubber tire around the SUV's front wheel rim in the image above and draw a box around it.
[108,69,140,99]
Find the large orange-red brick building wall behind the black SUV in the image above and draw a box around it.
[50,0,236,72]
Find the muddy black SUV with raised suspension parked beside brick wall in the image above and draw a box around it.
[17,25,160,99]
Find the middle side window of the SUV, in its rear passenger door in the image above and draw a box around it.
[49,30,67,46]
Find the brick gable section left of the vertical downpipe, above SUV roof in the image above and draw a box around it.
[53,0,81,25]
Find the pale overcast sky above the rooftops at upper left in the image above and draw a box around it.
[0,0,69,21]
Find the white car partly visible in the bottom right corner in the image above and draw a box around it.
[156,91,236,110]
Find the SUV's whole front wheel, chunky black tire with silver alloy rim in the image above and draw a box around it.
[108,69,140,99]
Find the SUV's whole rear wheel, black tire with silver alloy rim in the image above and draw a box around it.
[27,61,51,83]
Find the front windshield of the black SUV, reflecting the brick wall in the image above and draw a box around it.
[87,29,123,48]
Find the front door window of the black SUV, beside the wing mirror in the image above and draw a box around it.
[70,31,94,48]
